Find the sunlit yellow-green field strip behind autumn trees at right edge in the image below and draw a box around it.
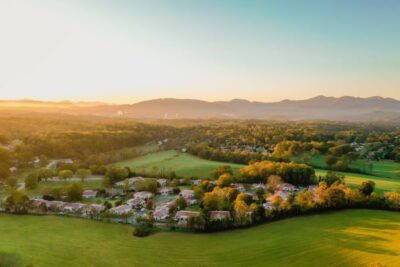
[315,169,400,194]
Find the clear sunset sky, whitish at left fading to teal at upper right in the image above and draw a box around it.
[0,0,400,102]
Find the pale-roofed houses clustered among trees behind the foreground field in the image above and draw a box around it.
[14,173,318,229]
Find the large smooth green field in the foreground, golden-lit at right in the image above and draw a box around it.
[0,210,400,267]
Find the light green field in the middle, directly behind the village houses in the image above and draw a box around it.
[114,150,244,178]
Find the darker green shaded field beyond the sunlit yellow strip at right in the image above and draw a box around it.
[293,155,400,180]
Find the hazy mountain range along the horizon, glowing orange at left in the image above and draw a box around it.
[0,96,400,122]
